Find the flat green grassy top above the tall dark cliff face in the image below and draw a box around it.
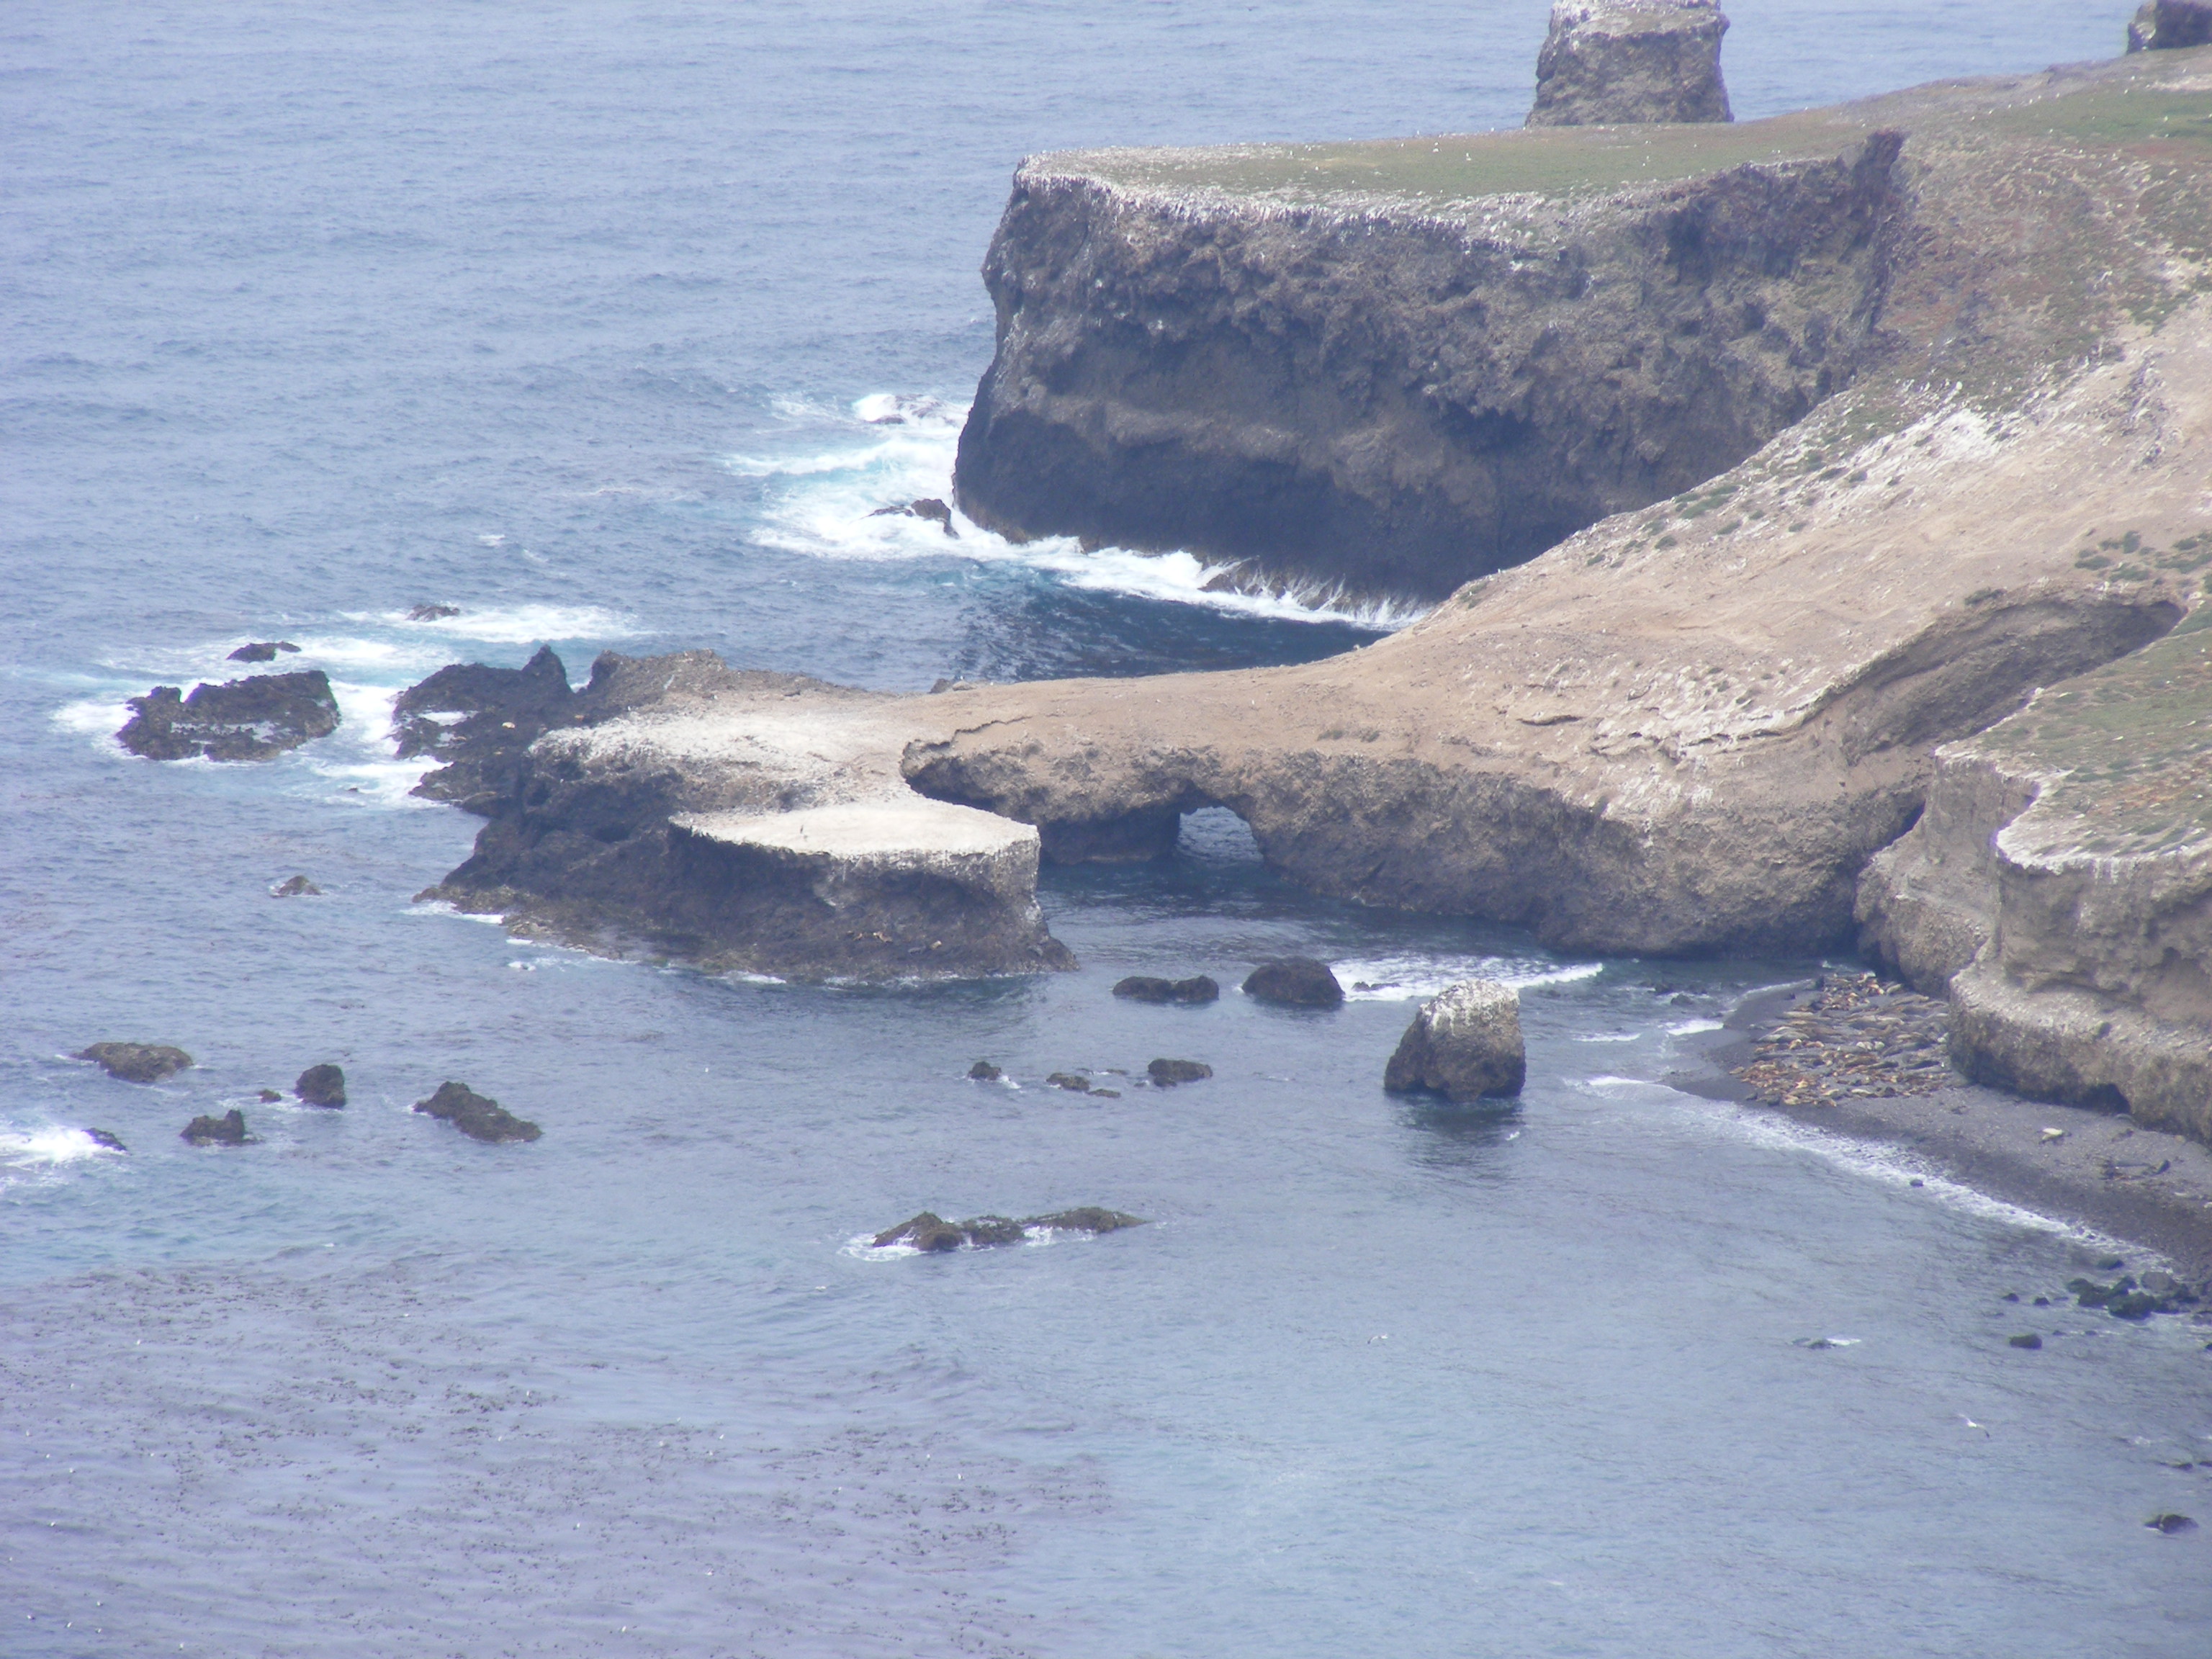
[1051,49,2212,206]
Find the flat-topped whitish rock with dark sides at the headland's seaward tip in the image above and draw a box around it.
[411,652,1073,980]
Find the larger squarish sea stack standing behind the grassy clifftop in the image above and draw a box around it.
[1529,0,1734,126]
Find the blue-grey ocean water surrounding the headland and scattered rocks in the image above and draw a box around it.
[0,0,2212,1659]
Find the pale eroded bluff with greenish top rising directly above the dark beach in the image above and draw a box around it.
[1858,610,2212,1139]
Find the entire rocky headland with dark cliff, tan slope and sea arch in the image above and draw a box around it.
[403,51,2212,1185]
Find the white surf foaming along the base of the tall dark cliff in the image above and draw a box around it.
[721,392,1426,628]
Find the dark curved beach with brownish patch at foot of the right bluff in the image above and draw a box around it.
[1663,980,2212,1292]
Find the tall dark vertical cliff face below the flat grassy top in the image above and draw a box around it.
[956,122,1900,600]
